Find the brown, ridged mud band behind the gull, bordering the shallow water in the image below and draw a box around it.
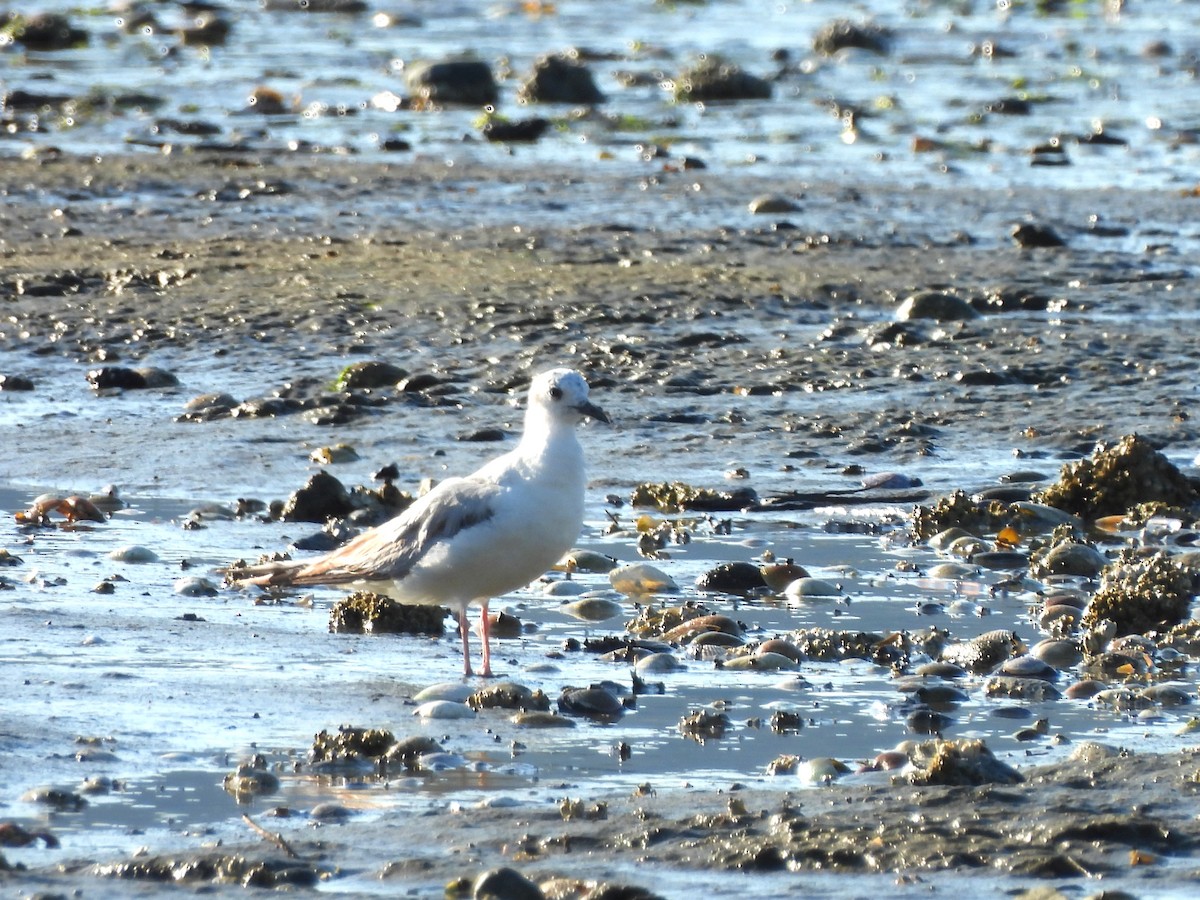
[7,150,1198,475]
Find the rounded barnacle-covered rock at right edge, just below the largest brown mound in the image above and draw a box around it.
[1082,552,1196,635]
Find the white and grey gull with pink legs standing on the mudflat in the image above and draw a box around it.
[232,368,610,677]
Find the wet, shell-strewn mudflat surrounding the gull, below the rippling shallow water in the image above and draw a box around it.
[0,151,1195,896]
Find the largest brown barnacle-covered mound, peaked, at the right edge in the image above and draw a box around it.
[1034,434,1200,518]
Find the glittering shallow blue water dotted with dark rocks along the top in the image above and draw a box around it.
[7,0,1200,198]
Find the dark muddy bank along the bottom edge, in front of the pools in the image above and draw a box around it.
[9,745,1200,896]
